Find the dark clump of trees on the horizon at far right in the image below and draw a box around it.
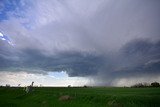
[131,82,160,88]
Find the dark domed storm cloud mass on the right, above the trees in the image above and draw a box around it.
[96,39,160,85]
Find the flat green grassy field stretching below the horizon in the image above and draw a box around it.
[0,87,160,107]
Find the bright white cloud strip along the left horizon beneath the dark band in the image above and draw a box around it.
[0,71,88,86]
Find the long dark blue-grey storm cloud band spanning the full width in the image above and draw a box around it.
[0,37,160,79]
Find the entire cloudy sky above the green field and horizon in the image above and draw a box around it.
[0,0,160,86]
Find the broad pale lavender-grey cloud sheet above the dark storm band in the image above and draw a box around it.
[0,0,159,53]
